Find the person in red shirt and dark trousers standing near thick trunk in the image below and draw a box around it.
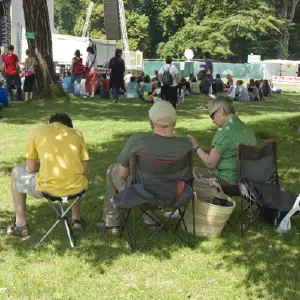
[2,45,22,100]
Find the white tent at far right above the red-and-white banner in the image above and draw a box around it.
[261,59,300,80]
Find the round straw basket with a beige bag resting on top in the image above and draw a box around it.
[184,169,235,237]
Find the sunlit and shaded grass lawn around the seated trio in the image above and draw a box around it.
[0,95,300,300]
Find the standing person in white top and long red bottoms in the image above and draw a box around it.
[84,46,98,98]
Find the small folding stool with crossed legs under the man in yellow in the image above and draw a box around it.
[39,189,85,248]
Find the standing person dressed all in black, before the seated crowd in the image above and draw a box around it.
[109,49,125,103]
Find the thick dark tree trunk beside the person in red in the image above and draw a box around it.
[23,0,62,99]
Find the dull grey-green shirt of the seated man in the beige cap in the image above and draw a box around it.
[117,133,192,168]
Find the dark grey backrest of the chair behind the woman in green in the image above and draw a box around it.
[237,140,279,183]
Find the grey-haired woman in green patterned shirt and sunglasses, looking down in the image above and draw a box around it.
[189,96,256,186]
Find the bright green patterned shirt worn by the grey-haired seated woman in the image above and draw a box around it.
[210,116,256,184]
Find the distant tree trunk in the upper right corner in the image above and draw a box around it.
[276,0,299,59]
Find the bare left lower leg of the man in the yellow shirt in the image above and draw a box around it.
[11,168,26,227]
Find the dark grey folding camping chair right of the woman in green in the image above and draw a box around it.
[222,140,279,237]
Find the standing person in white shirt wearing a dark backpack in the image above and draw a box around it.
[158,56,179,109]
